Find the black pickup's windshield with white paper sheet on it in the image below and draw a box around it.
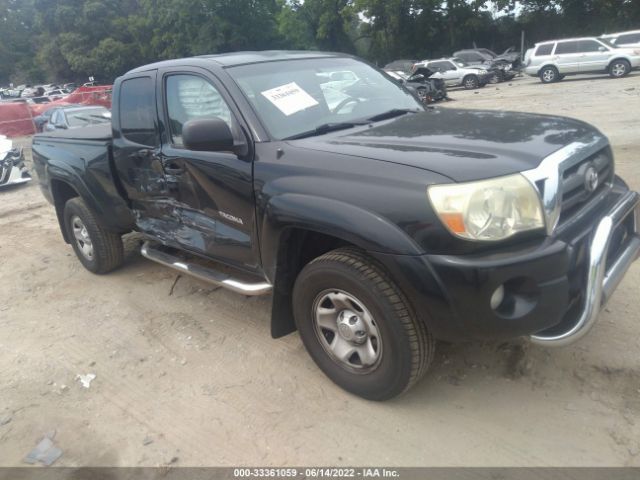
[228,58,424,140]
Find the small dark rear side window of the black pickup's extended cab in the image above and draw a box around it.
[119,77,158,147]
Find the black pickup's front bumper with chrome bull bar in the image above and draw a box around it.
[376,185,640,346]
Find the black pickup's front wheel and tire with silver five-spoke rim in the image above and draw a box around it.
[293,248,435,401]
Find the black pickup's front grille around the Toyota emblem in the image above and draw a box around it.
[560,147,614,224]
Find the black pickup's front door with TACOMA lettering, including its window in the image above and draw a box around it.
[158,67,259,271]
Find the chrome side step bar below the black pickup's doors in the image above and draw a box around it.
[140,242,273,296]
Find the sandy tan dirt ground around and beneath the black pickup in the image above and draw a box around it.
[0,73,640,466]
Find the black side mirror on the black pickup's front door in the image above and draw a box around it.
[182,117,234,152]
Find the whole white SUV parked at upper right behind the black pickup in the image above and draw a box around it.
[525,37,640,83]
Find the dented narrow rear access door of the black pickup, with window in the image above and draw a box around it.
[111,72,174,234]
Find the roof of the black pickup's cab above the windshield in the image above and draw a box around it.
[125,50,350,75]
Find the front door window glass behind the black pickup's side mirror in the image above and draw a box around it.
[165,75,234,146]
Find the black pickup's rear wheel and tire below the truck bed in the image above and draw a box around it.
[64,197,124,274]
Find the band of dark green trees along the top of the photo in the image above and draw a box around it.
[0,0,640,84]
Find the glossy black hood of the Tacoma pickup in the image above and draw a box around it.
[290,108,602,182]
